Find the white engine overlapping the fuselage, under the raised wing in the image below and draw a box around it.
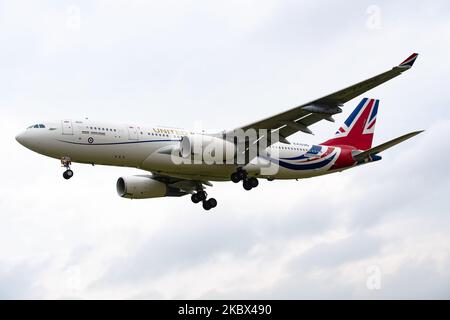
[180,134,236,162]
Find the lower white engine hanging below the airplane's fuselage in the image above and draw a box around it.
[116,176,186,199]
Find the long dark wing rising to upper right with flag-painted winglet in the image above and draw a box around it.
[232,53,418,144]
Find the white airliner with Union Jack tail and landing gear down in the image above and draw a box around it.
[16,53,423,210]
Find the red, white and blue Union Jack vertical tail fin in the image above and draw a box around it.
[321,98,380,150]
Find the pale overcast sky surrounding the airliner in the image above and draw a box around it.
[0,0,450,299]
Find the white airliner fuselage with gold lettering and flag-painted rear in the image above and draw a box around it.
[16,120,352,181]
